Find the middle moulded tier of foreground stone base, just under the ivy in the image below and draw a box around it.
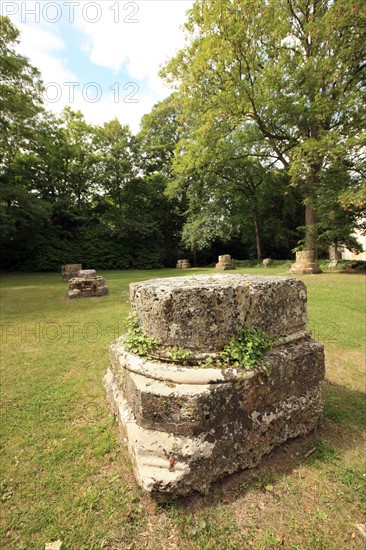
[111,338,324,435]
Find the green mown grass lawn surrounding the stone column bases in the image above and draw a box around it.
[0,267,366,550]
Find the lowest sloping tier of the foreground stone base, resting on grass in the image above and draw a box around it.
[104,370,322,499]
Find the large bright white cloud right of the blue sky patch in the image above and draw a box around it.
[76,0,193,103]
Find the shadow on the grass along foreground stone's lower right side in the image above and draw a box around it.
[165,381,366,511]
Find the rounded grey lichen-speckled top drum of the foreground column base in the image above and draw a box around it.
[130,274,306,351]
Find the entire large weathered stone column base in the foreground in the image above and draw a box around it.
[104,274,324,499]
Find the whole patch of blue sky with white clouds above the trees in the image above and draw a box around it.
[0,0,193,132]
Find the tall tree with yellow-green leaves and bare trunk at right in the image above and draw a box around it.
[163,0,366,272]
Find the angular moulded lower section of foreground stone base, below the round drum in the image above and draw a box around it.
[104,339,324,500]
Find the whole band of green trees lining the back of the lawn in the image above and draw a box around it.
[0,9,366,270]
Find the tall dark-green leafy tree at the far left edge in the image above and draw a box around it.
[0,16,49,242]
